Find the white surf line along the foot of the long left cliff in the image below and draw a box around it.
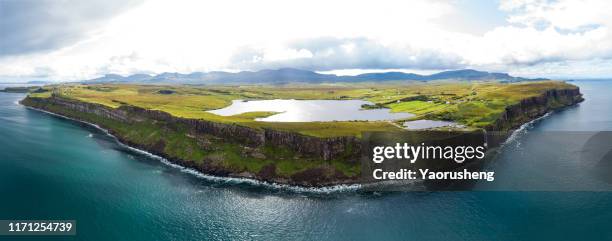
[27,106,361,194]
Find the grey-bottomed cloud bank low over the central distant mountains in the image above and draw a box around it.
[231,37,464,71]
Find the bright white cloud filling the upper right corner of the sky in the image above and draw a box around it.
[484,0,612,66]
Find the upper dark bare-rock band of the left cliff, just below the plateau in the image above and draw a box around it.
[21,96,361,160]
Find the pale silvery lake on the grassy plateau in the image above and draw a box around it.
[209,99,414,122]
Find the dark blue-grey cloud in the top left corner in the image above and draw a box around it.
[0,0,140,57]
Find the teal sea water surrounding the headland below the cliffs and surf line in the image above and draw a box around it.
[0,80,612,241]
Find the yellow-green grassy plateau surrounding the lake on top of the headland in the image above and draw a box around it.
[30,81,576,137]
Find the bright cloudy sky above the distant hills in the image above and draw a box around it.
[0,0,612,82]
